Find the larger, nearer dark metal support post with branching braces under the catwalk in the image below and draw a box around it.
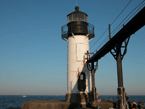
[109,25,130,109]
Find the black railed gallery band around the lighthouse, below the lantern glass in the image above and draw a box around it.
[61,23,95,40]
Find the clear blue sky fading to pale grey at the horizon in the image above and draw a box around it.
[0,0,145,95]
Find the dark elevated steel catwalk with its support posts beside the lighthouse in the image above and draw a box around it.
[87,7,145,109]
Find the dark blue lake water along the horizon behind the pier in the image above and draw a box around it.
[0,95,145,109]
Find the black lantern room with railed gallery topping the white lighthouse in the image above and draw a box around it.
[61,6,95,41]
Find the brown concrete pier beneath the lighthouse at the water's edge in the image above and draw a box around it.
[21,100,114,109]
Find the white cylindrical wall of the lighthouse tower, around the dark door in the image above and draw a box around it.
[67,35,92,93]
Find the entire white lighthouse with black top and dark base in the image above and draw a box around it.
[61,6,95,103]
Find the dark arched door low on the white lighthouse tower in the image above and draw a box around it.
[78,72,86,91]
